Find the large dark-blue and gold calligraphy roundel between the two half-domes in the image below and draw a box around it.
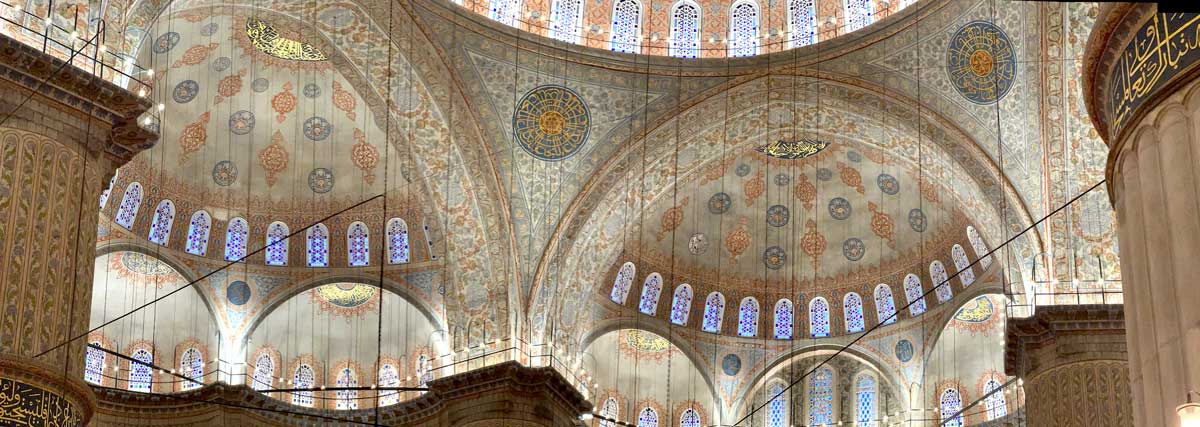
[512,85,592,162]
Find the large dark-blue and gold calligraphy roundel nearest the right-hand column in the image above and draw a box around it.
[946,20,1016,104]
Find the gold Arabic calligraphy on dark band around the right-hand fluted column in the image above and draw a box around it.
[1106,13,1200,134]
